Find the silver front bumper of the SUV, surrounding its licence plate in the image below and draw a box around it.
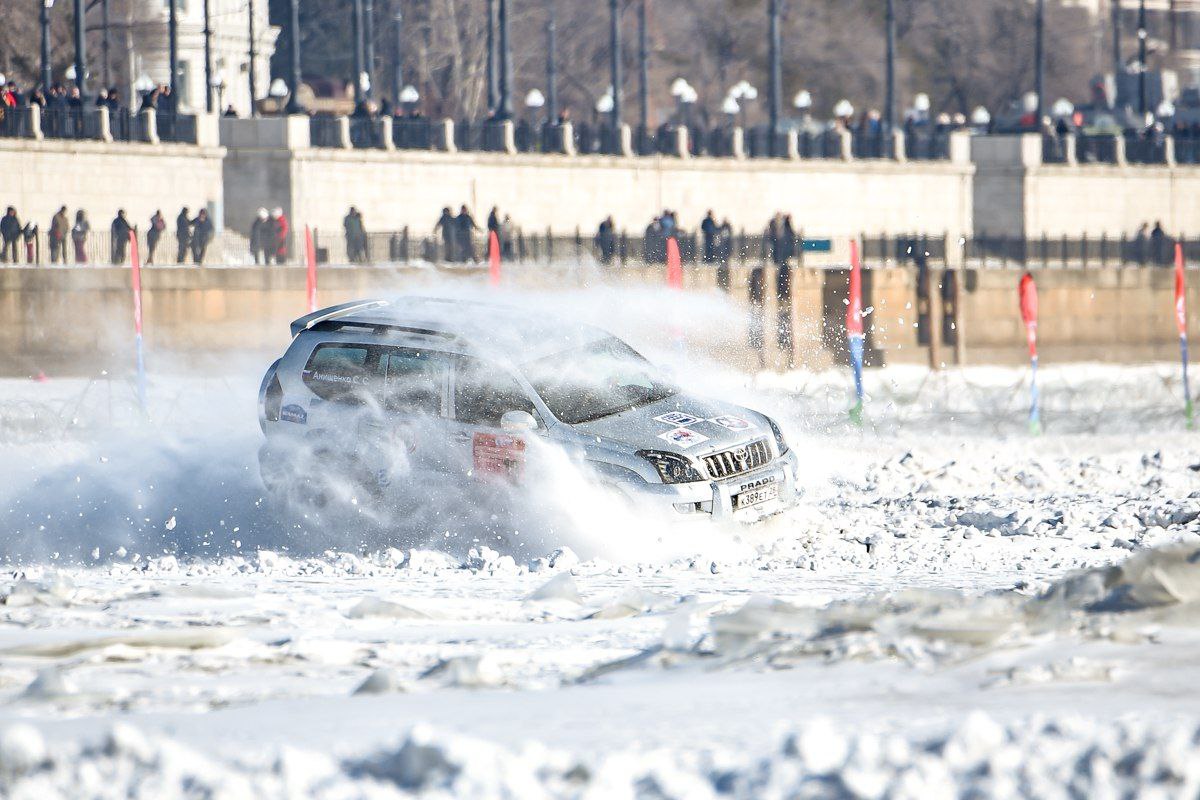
[620,450,800,522]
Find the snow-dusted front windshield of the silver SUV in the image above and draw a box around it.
[524,337,677,425]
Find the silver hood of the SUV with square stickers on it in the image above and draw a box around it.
[570,395,773,456]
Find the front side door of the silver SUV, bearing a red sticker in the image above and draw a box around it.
[449,356,546,481]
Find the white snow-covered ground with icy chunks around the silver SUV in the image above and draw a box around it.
[0,323,1200,798]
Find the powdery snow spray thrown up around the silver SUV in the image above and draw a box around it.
[0,284,787,563]
